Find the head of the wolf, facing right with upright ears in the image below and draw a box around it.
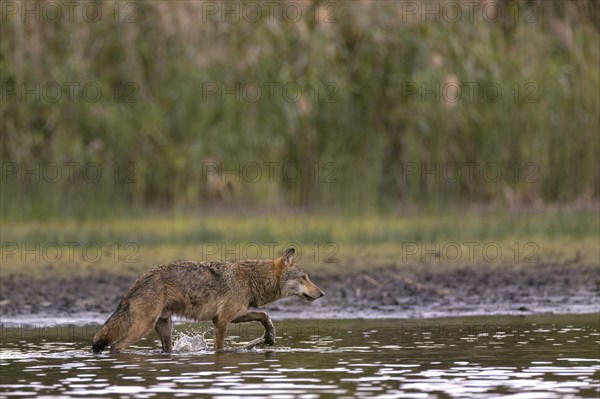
[275,248,325,301]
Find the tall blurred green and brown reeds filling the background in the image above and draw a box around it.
[0,0,600,219]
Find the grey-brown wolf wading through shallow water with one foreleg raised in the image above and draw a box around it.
[92,248,325,353]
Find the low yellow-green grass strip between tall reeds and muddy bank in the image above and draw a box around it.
[1,213,600,276]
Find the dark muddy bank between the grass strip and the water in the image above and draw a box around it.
[0,262,600,321]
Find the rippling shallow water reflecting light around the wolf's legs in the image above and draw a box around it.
[0,315,600,399]
